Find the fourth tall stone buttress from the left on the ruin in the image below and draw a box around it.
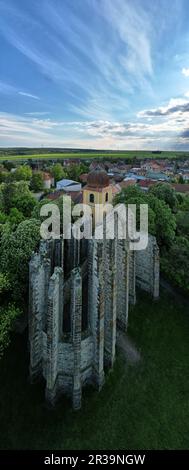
[88,239,105,390]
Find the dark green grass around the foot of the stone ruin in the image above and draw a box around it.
[0,294,189,450]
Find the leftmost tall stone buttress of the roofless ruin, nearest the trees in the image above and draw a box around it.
[29,254,51,382]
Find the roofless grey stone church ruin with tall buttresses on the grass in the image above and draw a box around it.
[29,228,159,409]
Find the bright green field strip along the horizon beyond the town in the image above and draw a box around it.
[0,149,189,161]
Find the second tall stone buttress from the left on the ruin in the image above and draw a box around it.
[46,268,63,405]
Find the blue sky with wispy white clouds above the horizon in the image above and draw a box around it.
[0,0,189,150]
